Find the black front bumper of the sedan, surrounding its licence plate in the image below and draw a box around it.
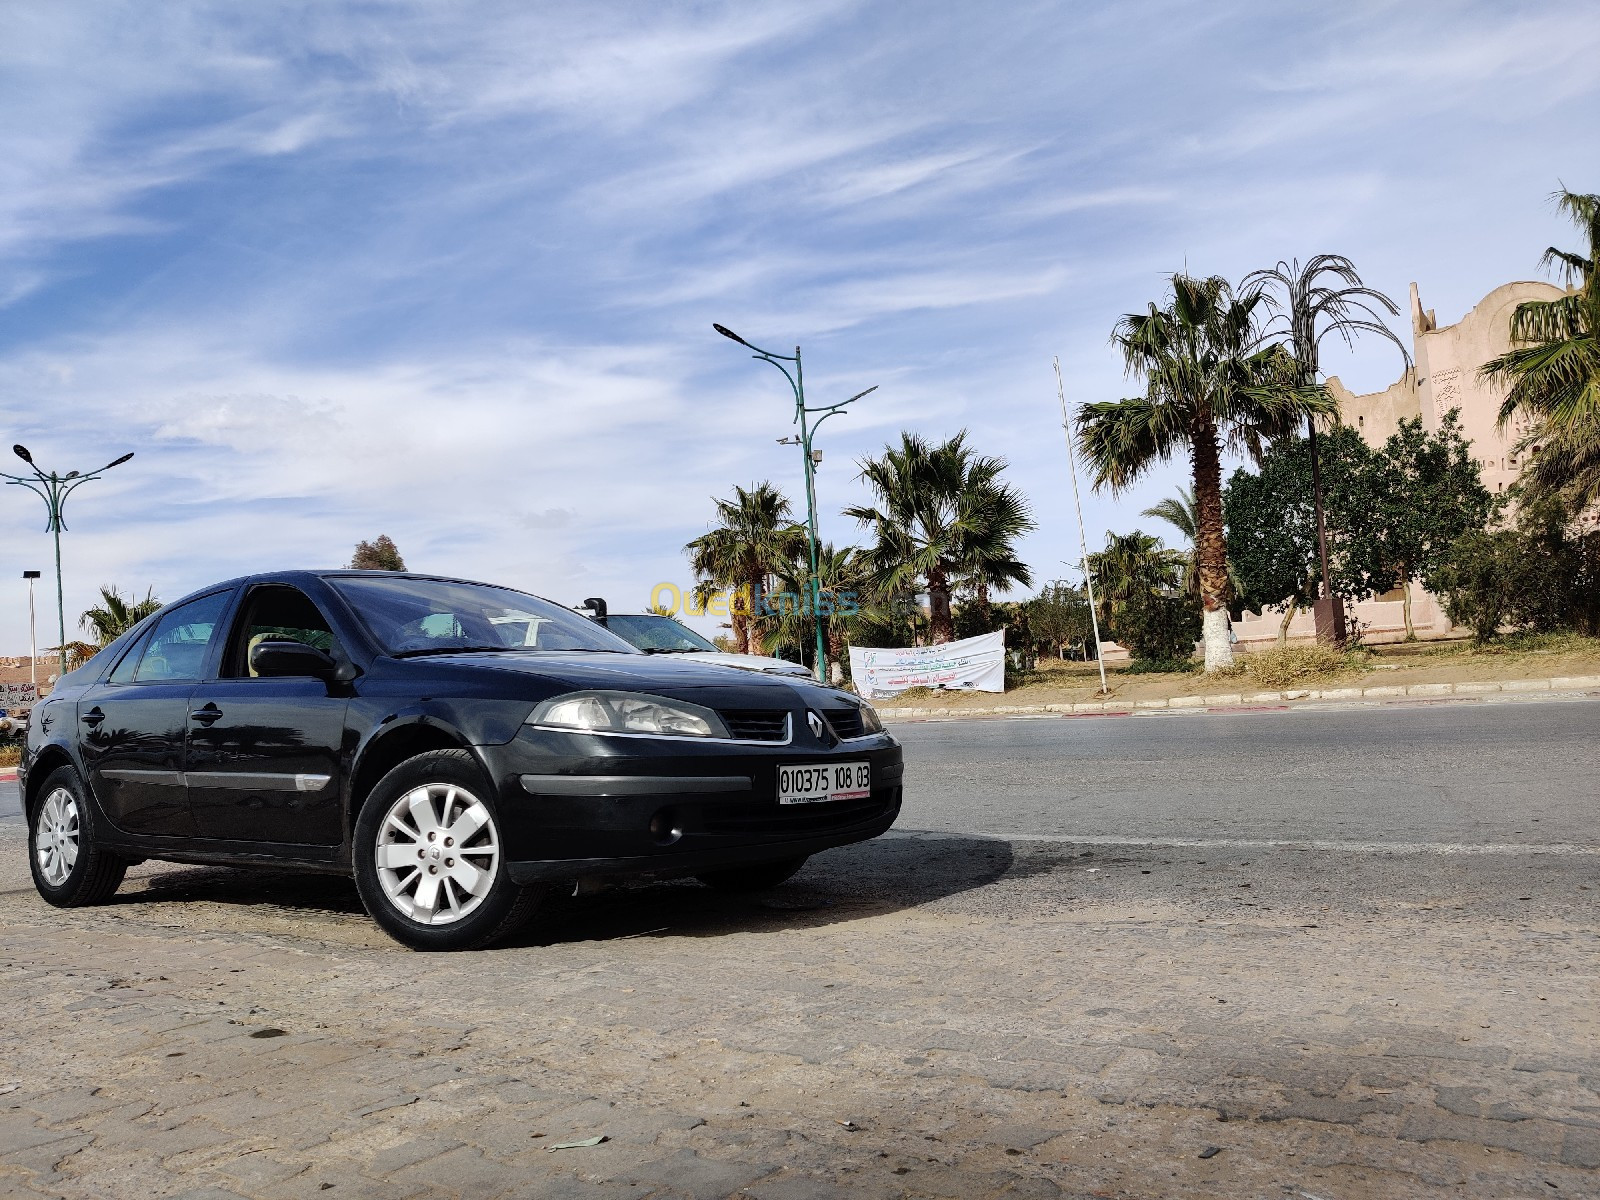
[478,730,904,883]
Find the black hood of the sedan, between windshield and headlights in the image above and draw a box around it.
[434,651,842,709]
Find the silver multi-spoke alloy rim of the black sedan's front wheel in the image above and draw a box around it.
[373,784,499,925]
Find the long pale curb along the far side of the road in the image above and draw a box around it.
[878,675,1600,722]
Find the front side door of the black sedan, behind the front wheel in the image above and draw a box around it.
[186,584,349,846]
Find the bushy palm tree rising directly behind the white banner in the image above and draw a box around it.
[845,429,1034,645]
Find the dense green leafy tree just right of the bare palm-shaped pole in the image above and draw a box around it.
[1363,408,1494,642]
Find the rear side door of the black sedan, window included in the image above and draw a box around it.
[78,590,232,837]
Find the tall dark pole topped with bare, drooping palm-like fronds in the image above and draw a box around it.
[1245,254,1411,642]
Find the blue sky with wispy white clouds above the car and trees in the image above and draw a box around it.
[0,0,1600,654]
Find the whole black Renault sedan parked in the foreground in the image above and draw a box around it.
[19,571,902,949]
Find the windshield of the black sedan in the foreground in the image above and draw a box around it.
[328,576,637,654]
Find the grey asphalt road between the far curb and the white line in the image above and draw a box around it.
[894,701,1600,851]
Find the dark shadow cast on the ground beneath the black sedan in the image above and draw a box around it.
[112,832,1013,947]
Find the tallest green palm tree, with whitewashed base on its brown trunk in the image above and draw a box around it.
[1078,275,1338,670]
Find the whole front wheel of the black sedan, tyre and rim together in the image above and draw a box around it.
[354,750,542,950]
